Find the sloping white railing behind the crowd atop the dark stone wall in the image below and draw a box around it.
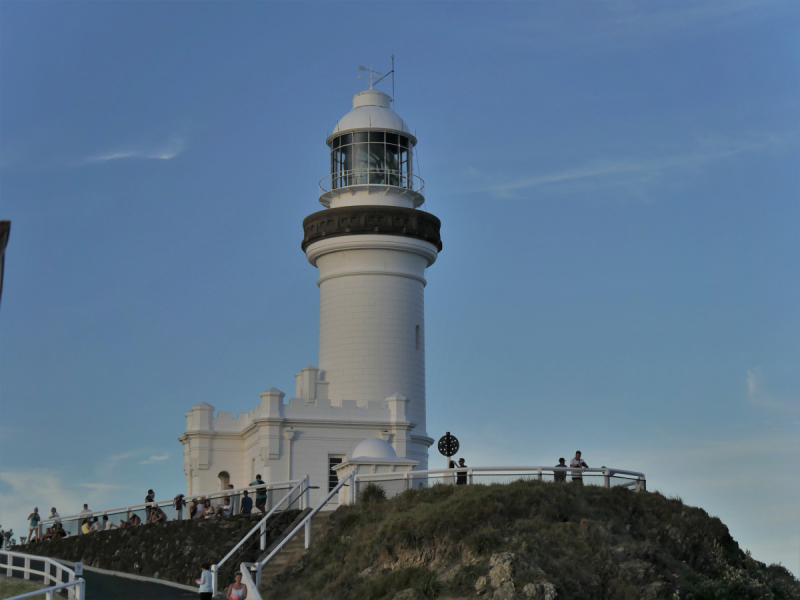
[38,479,304,539]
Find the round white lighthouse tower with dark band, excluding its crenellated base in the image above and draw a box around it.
[302,82,442,468]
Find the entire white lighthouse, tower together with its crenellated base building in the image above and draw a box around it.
[179,79,442,500]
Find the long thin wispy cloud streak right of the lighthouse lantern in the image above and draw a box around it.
[469,134,794,198]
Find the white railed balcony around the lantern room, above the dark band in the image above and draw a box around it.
[319,169,425,208]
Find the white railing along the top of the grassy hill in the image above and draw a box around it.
[340,467,647,504]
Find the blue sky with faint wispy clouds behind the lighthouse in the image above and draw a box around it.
[0,0,800,575]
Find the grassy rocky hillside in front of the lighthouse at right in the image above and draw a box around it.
[262,481,800,600]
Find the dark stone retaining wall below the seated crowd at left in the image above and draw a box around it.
[12,510,301,588]
